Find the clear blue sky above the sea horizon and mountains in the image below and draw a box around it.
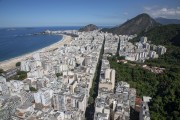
[0,0,180,27]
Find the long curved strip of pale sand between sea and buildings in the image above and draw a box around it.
[0,35,72,70]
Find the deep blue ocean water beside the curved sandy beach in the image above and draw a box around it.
[0,27,80,61]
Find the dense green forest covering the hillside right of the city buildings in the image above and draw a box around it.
[112,25,180,120]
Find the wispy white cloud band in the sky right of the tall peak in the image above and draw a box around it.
[144,6,180,19]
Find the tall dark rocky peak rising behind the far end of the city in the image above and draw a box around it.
[101,13,160,35]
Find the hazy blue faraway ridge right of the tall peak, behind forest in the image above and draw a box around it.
[155,17,180,25]
